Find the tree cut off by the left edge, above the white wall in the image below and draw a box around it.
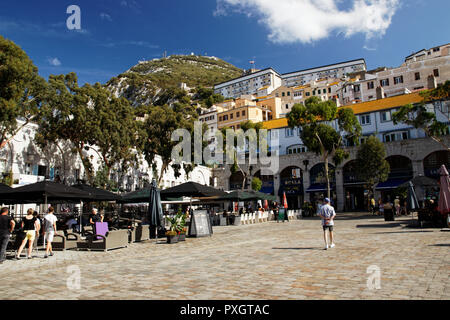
[0,36,46,149]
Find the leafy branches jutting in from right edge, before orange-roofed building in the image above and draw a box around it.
[392,81,450,150]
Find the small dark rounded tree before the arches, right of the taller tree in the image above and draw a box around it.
[356,136,390,198]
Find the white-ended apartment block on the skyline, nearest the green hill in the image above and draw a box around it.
[214,68,282,98]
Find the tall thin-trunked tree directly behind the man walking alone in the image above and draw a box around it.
[287,97,361,198]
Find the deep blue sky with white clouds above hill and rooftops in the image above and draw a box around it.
[0,0,450,83]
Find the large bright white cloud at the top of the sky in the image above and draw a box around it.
[214,0,400,43]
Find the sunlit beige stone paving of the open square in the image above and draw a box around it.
[0,214,450,300]
